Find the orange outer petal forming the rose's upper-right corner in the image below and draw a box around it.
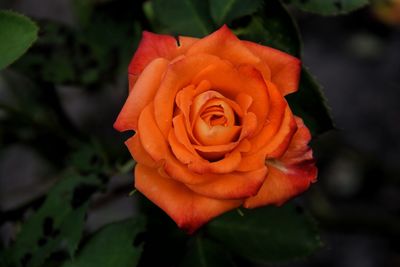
[242,41,301,95]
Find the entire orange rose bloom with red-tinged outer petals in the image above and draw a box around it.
[114,26,317,233]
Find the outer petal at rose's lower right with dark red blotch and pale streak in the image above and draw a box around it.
[244,118,317,208]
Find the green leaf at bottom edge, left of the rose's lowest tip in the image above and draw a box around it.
[63,218,145,267]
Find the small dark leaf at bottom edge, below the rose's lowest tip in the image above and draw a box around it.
[180,236,235,267]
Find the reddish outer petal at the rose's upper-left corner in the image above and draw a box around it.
[128,31,197,88]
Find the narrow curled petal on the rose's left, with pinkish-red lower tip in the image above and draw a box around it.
[114,58,168,131]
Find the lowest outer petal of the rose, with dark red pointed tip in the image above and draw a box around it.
[135,164,242,233]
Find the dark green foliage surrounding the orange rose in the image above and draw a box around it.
[0,0,376,267]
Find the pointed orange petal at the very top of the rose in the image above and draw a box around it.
[186,25,260,65]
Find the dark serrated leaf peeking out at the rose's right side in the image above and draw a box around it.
[286,68,334,135]
